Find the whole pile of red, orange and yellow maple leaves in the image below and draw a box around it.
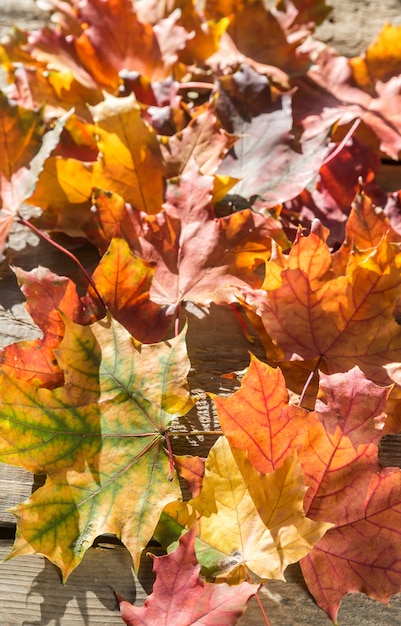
[0,0,401,626]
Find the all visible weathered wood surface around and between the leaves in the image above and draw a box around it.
[0,0,401,626]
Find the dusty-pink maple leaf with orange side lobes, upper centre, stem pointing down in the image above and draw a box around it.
[119,170,282,311]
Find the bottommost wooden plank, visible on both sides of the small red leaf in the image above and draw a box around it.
[0,539,401,626]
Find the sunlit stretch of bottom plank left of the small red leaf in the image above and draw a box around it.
[0,540,144,626]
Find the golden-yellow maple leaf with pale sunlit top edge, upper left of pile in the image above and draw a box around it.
[29,96,164,227]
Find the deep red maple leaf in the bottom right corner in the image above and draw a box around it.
[301,468,401,622]
